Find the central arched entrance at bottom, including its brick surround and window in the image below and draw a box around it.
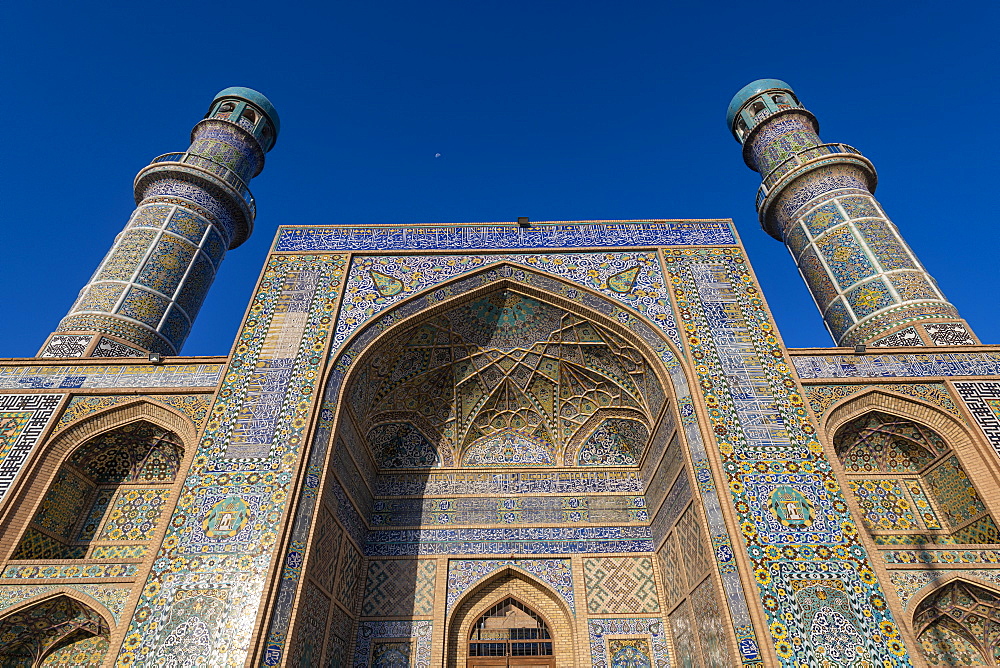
[445,568,577,668]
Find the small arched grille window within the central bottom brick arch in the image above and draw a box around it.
[469,598,552,656]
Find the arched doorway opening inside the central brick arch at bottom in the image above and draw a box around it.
[466,598,556,668]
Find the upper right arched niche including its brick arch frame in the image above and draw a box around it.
[826,390,1000,545]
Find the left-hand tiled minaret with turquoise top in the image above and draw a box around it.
[39,88,279,357]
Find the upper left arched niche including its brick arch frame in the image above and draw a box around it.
[5,401,195,560]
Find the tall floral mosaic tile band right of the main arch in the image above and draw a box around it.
[665,249,908,667]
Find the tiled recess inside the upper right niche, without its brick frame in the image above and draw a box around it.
[833,411,1000,545]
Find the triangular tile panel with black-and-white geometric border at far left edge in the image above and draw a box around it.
[0,394,65,500]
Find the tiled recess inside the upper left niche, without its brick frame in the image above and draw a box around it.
[12,420,184,559]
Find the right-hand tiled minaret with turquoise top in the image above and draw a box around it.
[726,79,977,346]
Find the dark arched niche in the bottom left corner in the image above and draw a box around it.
[0,593,110,668]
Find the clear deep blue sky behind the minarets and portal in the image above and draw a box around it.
[0,0,1000,356]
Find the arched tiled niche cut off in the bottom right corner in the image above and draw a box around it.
[913,581,1000,666]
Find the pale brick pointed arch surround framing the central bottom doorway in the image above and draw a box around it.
[445,564,582,668]
